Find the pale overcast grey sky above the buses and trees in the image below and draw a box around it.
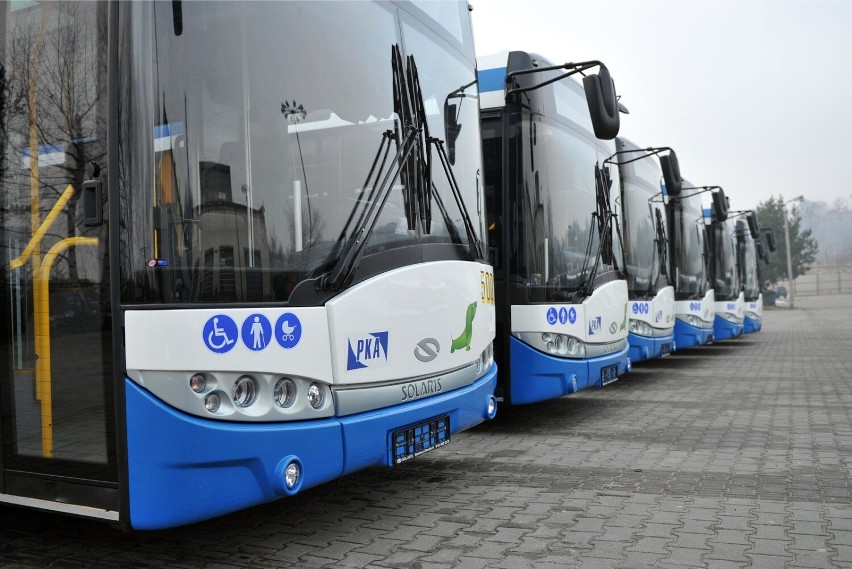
[470,0,852,209]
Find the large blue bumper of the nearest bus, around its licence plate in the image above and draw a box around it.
[125,365,497,530]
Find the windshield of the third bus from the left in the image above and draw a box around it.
[621,155,667,296]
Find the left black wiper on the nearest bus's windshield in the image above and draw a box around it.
[321,45,421,291]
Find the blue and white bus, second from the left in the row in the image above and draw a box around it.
[478,51,629,405]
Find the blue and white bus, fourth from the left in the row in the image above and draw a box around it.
[667,181,721,350]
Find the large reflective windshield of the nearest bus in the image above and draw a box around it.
[120,2,482,303]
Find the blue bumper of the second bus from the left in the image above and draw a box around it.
[504,337,630,405]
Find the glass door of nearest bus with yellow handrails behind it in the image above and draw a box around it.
[0,1,118,517]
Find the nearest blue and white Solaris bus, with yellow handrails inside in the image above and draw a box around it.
[0,1,496,529]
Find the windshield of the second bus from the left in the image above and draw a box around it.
[500,114,621,302]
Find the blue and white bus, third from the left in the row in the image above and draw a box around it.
[605,141,683,362]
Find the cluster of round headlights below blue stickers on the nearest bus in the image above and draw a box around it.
[188,372,328,419]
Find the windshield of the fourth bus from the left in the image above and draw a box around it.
[671,197,708,299]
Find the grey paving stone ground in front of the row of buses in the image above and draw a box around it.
[0,296,852,569]
